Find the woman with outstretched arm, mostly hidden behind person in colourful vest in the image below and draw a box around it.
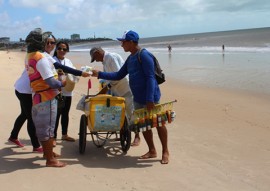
[8,32,90,156]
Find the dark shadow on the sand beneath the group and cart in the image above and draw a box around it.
[0,140,156,174]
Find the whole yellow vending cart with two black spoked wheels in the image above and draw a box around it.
[79,80,131,154]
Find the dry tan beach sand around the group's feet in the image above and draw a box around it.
[0,51,270,191]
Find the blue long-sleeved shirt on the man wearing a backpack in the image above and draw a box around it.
[98,50,161,105]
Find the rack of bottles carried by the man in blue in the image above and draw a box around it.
[129,100,177,133]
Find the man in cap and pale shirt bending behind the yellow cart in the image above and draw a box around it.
[90,47,140,146]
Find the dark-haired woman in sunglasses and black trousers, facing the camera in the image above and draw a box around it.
[53,41,75,142]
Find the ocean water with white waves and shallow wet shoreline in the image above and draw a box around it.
[67,28,270,94]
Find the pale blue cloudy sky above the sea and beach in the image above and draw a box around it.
[0,0,270,41]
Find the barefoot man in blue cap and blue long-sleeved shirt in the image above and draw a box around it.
[92,30,169,164]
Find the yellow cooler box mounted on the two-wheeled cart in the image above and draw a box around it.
[88,94,125,132]
